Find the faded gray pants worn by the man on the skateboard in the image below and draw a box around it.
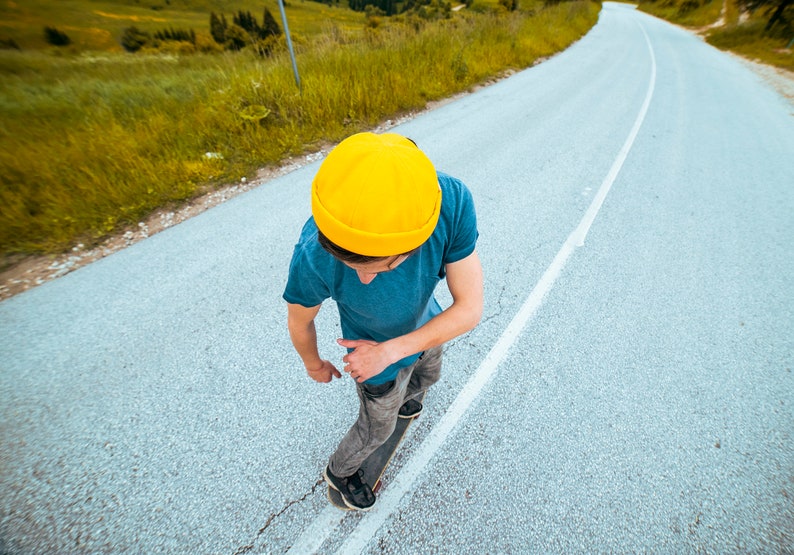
[328,347,442,478]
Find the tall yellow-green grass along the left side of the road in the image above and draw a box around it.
[0,0,599,255]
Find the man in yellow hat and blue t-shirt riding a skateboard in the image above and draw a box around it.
[284,133,483,510]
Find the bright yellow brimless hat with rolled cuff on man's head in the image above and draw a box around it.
[312,133,441,256]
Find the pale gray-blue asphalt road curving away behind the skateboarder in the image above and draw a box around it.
[0,3,794,555]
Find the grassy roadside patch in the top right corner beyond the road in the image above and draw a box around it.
[639,0,794,71]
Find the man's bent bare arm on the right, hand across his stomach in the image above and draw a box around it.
[338,251,483,382]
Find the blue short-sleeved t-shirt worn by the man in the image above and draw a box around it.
[283,172,478,385]
